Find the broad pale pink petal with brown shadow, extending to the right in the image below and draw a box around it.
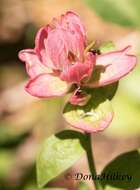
[88,46,137,87]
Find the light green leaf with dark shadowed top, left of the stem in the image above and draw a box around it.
[37,130,85,187]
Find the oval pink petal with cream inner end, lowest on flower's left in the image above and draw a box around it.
[25,73,68,98]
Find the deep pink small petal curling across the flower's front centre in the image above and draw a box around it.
[60,53,95,84]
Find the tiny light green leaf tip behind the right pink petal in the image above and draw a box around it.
[99,42,116,53]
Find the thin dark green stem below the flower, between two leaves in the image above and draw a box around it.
[86,133,103,190]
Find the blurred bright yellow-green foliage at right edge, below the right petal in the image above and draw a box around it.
[105,59,140,138]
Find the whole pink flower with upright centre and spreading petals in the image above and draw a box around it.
[19,11,136,132]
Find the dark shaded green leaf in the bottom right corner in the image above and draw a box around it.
[101,150,140,190]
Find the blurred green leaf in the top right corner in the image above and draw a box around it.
[84,0,140,27]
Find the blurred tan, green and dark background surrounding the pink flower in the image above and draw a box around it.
[0,0,140,190]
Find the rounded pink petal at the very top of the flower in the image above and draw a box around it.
[61,11,86,44]
